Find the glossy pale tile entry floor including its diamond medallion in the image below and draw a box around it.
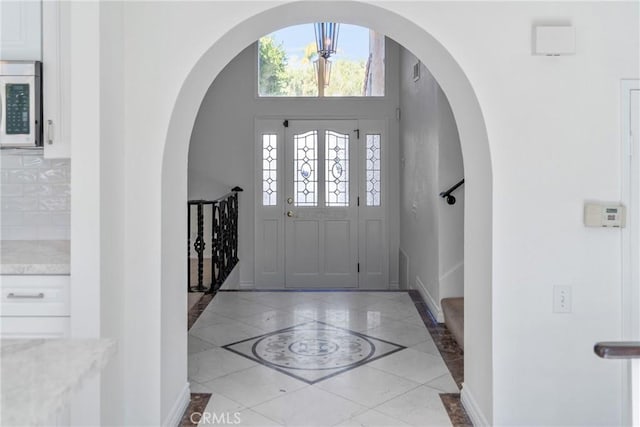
[188,291,469,427]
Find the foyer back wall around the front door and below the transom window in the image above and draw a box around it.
[189,40,399,286]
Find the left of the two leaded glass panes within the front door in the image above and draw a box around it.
[293,130,318,206]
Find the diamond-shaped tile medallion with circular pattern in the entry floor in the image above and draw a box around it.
[222,321,406,384]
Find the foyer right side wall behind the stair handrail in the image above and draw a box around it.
[400,49,464,321]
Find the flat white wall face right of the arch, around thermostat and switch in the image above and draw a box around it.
[433,3,640,425]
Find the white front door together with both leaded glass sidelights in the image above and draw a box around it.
[255,119,390,289]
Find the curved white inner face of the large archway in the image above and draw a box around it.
[160,2,493,422]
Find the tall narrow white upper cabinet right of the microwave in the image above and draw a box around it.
[42,0,71,158]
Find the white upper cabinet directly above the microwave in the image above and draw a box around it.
[0,0,42,61]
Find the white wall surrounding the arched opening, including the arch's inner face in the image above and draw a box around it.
[63,1,640,425]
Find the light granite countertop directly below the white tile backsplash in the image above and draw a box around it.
[0,240,70,274]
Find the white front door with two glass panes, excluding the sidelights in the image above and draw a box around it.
[284,120,358,288]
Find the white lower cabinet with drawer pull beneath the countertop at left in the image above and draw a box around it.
[0,276,70,339]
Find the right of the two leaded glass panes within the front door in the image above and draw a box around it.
[324,130,349,206]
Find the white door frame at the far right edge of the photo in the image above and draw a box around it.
[620,79,640,425]
